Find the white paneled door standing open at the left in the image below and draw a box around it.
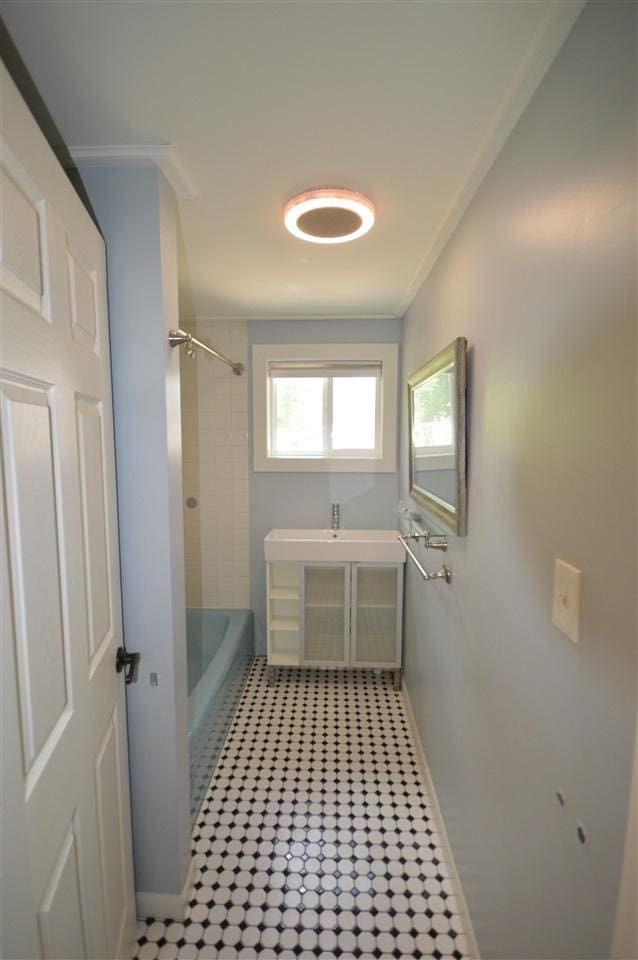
[0,67,135,960]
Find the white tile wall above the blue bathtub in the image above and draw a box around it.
[181,320,249,608]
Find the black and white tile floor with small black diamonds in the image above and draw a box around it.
[136,658,468,960]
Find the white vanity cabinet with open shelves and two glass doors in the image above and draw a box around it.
[267,561,403,685]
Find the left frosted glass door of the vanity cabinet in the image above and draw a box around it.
[302,563,350,666]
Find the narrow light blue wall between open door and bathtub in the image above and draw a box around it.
[75,167,190,908]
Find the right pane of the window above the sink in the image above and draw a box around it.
[332,377,377,450]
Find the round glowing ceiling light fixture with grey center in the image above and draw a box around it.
[284,187,374,243]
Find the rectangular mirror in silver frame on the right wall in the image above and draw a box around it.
[408,337,467,536]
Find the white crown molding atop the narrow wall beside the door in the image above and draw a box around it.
[63,143,200,200]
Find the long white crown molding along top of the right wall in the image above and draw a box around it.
[396,0,586,317]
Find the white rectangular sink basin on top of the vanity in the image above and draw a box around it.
[264,530,405,563]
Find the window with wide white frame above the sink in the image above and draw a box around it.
[253,344,397,472]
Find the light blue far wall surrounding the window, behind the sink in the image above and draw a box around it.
[248,320,401,653]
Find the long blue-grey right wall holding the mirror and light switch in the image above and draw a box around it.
[401,3,636,960]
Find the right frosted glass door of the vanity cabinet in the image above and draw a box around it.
[351,563,403,667]
